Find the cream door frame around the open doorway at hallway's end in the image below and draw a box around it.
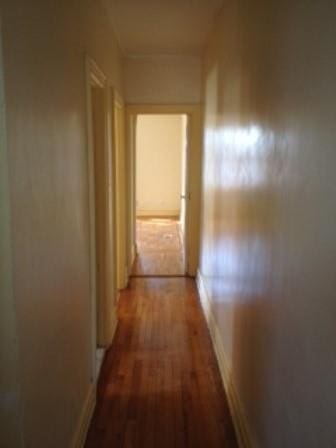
[126,104,202,277]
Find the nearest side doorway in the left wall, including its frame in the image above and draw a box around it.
[86,58,117,382]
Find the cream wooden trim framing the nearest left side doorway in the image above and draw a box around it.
[85,55,117,374]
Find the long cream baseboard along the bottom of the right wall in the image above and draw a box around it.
[197,271,256,448]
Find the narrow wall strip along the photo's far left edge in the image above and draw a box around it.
[0,22,22,448]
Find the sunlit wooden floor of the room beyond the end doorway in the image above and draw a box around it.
[132,218,185,276]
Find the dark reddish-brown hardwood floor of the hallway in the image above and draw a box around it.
[85,278,238,448]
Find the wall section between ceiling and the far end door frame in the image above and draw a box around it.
[124,55,201,104]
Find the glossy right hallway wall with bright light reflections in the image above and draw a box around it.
[201,0,336,448]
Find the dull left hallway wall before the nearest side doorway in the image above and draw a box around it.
[0,0,122,448]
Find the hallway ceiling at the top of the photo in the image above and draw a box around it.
[105,0,223,55]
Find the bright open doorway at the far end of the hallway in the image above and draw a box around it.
[132,114,188,276]
